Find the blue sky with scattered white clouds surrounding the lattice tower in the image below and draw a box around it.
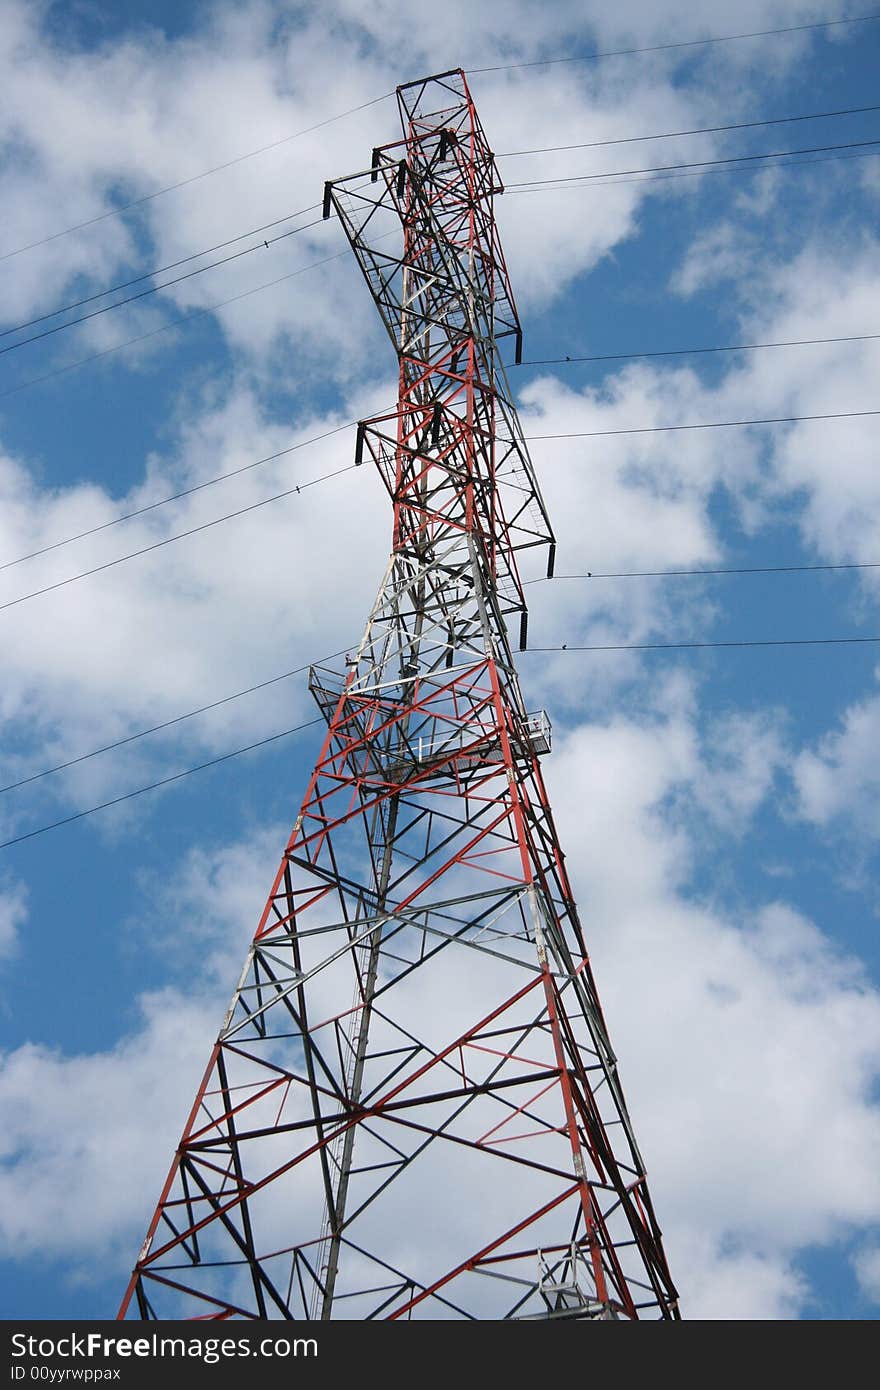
[0,0,880,1319]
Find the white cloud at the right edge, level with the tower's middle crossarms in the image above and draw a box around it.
[656,215,880,569]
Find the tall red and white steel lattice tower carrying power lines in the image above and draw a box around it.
[120,71,678,1319]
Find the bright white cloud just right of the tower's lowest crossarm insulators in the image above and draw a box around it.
[520,367,722,709]
